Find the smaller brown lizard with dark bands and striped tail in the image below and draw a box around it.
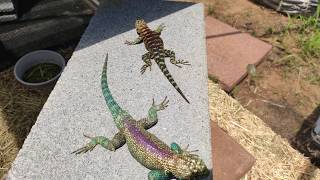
[125,19,190,103]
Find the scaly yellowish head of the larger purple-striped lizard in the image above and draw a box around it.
[171,151,209,179]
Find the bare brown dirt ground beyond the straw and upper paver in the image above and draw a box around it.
[204,0,320,162]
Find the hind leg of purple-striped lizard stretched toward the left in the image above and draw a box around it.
[72,132,126,154]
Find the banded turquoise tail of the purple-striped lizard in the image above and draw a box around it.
[101,54,123,119]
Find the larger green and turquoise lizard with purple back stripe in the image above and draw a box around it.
[72,55,209,180]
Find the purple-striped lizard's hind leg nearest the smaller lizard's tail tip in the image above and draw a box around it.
[138,97,169,129]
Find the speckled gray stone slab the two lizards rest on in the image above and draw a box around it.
[8,0,212,180]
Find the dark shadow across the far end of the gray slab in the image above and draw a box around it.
[78,0,194,49]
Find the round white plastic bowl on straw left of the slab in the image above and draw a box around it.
[14,50,65,87]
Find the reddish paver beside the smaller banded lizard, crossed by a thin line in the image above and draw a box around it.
[206,16,272,92]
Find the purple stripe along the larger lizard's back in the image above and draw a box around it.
[125,122,172,158]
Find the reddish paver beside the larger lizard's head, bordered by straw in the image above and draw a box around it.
[211,122,255,180]
